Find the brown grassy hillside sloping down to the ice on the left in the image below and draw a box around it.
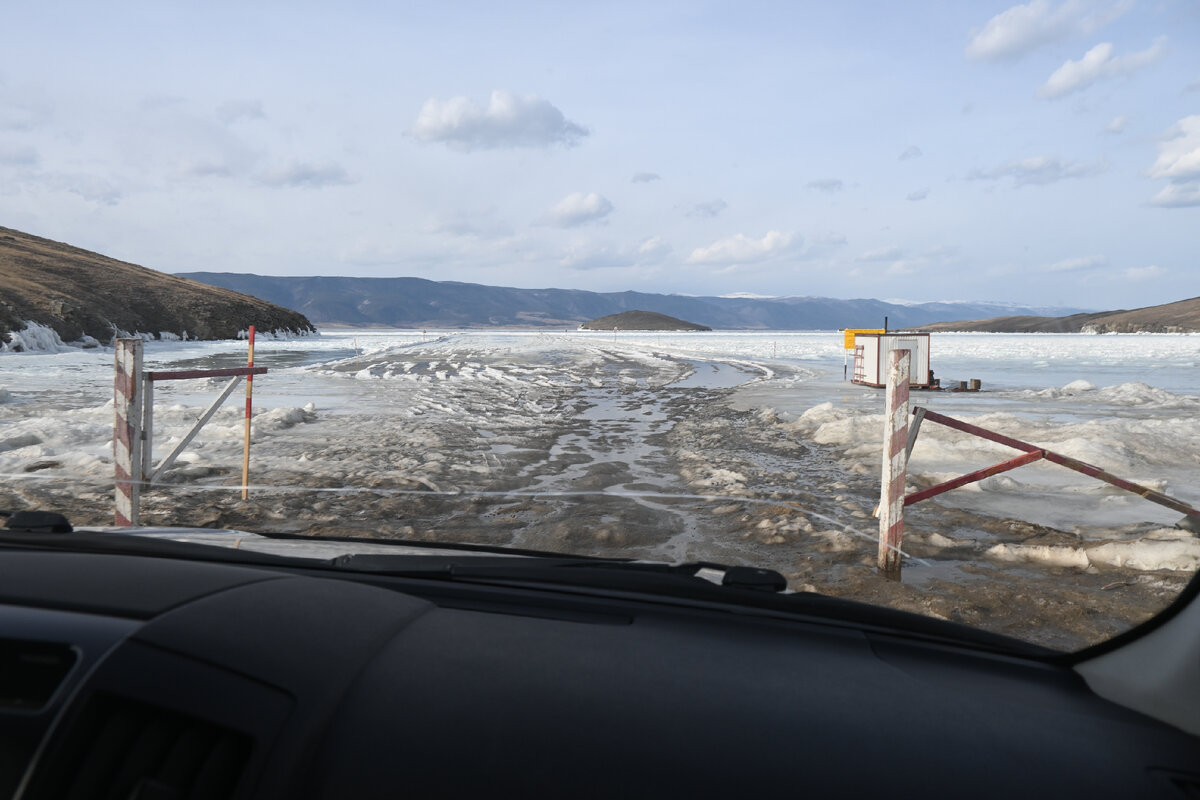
[0,227,313,343]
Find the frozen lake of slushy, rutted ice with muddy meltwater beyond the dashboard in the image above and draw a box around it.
[0,330,1200,644]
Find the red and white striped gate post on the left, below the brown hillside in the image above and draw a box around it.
[113,339,142,525]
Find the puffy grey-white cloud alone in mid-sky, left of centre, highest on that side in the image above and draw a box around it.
[410,89,588,151]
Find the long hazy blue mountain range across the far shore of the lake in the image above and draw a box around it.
[180,272,1099,330]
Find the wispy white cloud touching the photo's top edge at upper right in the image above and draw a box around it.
[966,0,1132,60]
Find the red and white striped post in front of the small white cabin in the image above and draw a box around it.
[878,350,912,581]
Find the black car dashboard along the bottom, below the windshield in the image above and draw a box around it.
[0,534,1200,799]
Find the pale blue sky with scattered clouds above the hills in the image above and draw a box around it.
[0,0,1200,309]
